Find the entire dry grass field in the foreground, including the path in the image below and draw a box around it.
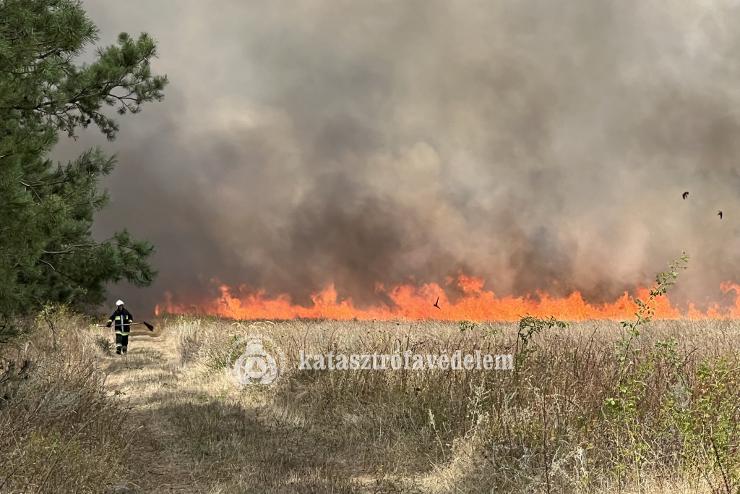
[0,310,740,493]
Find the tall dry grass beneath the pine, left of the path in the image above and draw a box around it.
[0,309,143,492]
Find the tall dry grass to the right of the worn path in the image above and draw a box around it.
[174,320,740,494]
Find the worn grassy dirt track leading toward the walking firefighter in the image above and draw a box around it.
[99,331,399,493]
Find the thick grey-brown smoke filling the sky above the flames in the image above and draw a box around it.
[57,0,740,311]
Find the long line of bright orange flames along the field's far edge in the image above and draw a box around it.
[155,275,740,321]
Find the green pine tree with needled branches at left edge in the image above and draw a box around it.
[0,0,167,328]
